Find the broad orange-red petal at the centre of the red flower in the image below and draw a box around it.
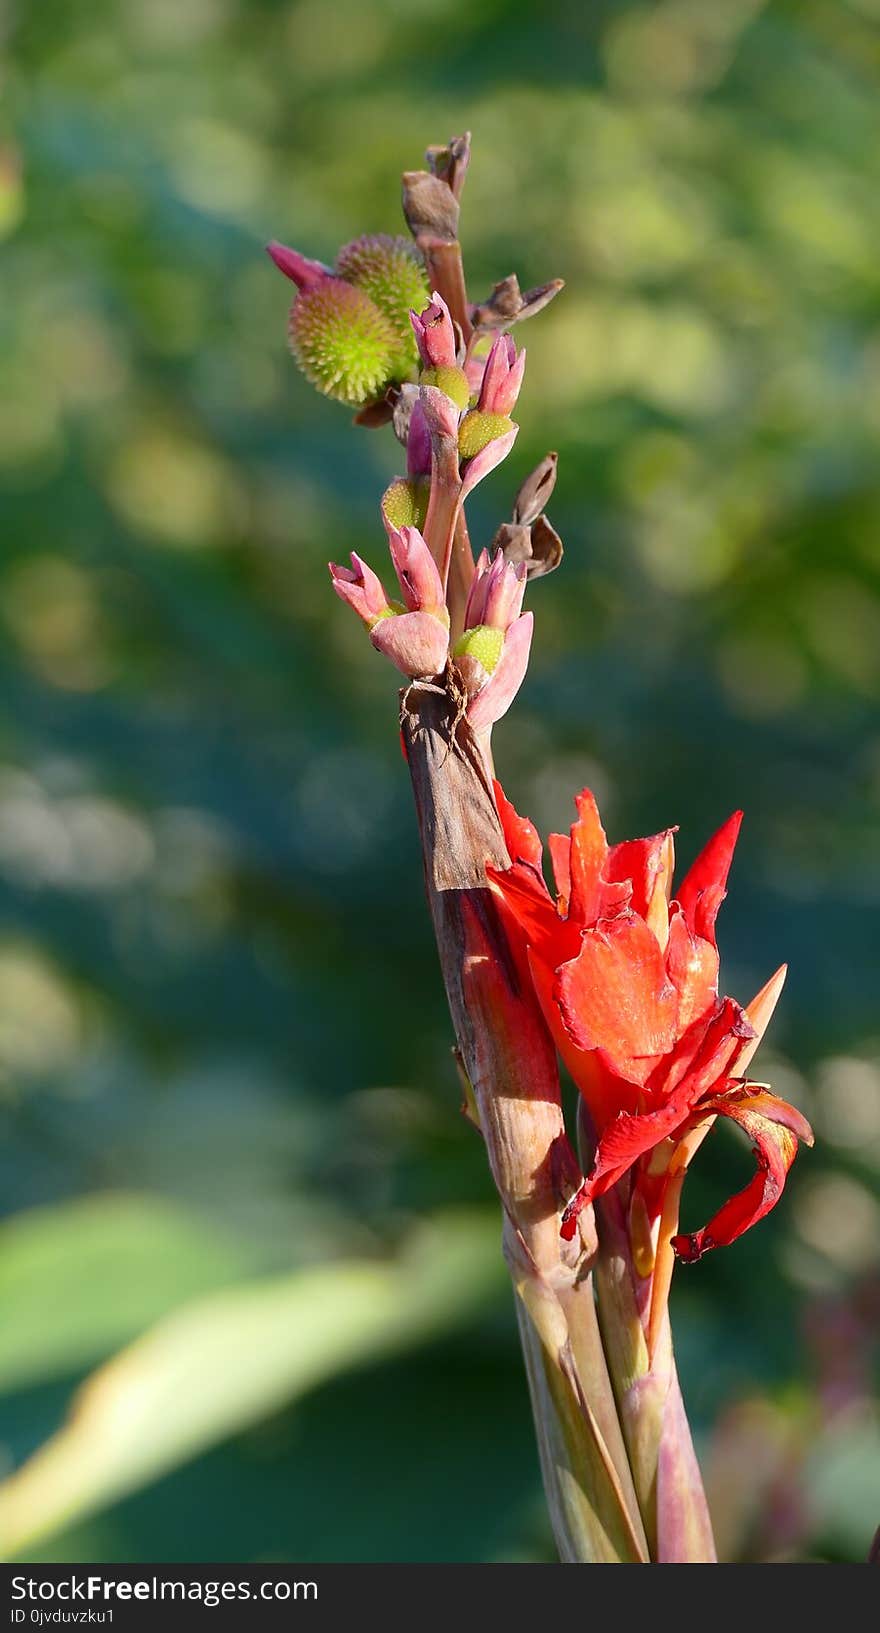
[555,913,678,1083]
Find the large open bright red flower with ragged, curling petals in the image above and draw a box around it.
[490,787,813,1261]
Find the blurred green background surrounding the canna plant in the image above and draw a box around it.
[0,0,880,1561]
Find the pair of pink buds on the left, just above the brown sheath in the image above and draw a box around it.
[330,526,449,679]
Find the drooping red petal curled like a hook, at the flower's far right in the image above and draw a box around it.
[673,1084,813,1264]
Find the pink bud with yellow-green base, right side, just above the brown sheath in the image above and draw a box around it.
[452,550,534,732]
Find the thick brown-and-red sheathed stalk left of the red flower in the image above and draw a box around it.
[402,684,648,1563]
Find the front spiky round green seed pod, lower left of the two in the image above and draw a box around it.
[287,278,398,408]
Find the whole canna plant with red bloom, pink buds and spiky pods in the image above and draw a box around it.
[269,137,811,1563]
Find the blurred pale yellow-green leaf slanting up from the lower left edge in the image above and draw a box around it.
[0,1213,503,1558]
